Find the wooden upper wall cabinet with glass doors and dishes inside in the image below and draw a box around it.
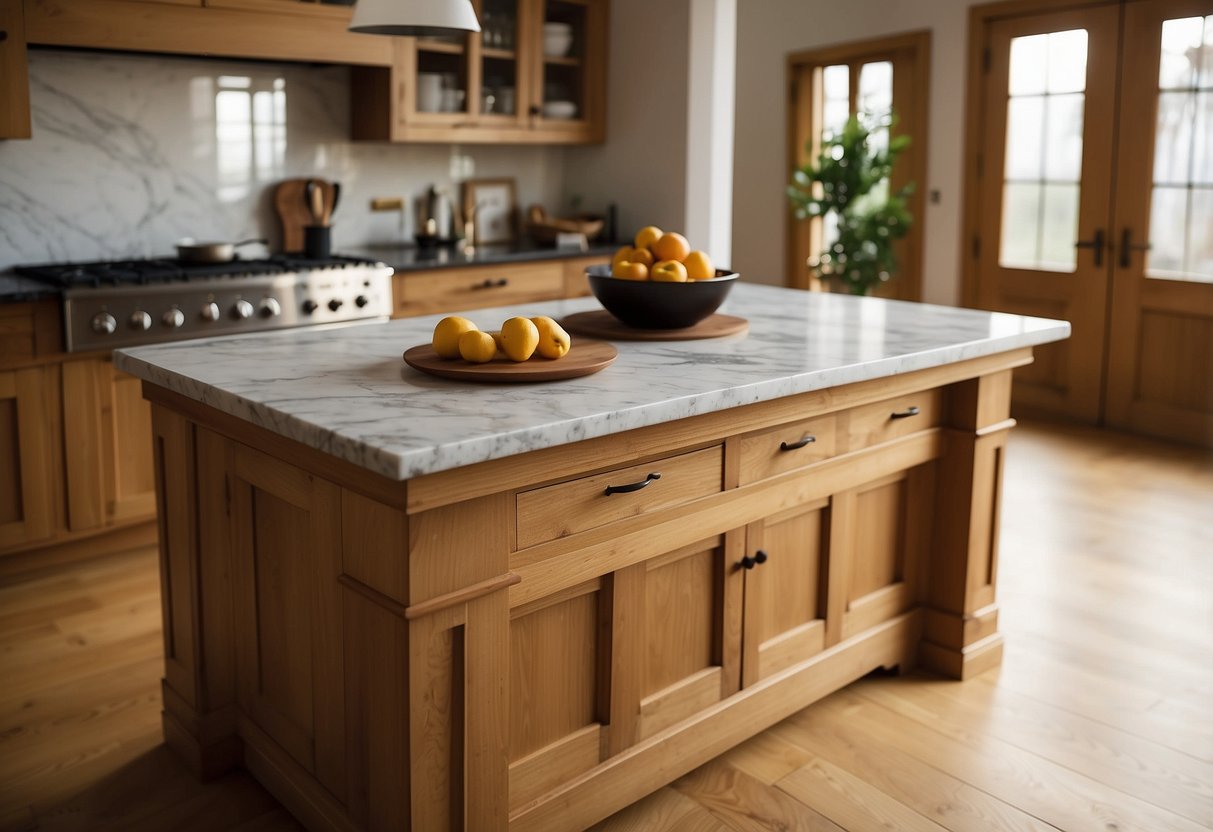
[352,0,608,144]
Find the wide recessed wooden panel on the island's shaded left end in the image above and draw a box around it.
[229,445,346,797]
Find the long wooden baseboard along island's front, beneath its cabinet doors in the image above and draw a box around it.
[509,610,922,832]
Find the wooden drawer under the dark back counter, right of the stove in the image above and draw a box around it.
[392,262,564,317]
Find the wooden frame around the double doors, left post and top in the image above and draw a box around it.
[957,0,1123,308]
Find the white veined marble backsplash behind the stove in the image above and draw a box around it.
[0,50,564,270]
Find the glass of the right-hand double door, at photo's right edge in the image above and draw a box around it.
[1145,15,1213,283]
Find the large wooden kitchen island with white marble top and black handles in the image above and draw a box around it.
[115,284,1069,831]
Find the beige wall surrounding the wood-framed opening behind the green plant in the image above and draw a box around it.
[733,0,973,303]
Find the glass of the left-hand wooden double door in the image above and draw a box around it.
[998,29,1087,272]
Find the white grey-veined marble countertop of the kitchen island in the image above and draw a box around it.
[114,283,1070,479]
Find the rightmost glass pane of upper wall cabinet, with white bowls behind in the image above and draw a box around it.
[541,0,587,121]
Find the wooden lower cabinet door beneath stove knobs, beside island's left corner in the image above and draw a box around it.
[63,359,155,531]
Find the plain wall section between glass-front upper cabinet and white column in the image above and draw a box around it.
[562,0,690,247]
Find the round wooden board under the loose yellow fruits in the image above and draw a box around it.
[404,338,619,383]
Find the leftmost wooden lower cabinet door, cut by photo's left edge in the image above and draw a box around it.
[0,367,59,548]
